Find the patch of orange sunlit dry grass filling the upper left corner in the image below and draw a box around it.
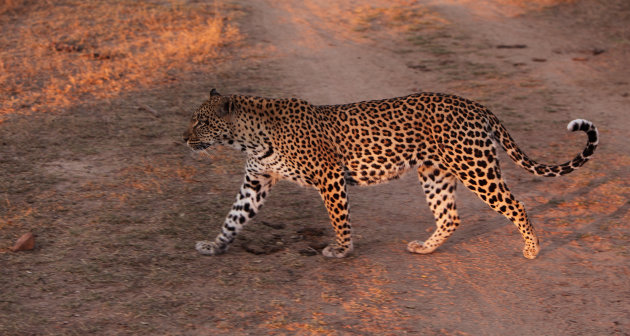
[0,0,240,116]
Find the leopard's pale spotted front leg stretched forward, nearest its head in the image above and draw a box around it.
[196,171,276,255]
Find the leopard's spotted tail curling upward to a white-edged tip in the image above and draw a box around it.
[493,117,599,176]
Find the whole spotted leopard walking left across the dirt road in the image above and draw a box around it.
[183,89,599,259]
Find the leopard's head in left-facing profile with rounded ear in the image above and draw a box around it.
[184,89,232,150]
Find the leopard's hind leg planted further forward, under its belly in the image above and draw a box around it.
[407,162,459,254]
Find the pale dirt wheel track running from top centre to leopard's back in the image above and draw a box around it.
[241,1,424,104]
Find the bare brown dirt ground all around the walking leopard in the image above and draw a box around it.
[0,0,630,335]
